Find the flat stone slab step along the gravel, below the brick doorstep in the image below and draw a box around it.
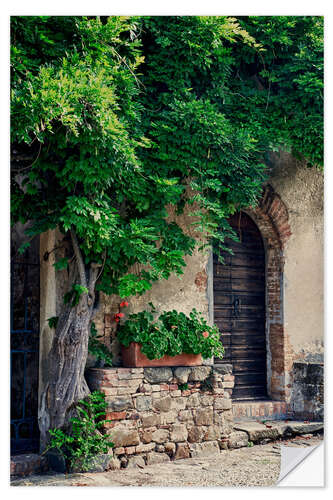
[234,420,324,443]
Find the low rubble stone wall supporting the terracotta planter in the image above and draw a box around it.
[86,365,234,467]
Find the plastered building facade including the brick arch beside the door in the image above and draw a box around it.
[84,153,324,415]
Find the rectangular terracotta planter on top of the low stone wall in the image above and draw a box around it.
[121,342,202,368]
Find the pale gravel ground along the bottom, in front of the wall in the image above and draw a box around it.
[11,435,322,487]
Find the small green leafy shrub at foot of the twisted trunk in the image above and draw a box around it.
[44,391,114,472]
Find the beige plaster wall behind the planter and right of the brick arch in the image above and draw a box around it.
[94,153,324,365]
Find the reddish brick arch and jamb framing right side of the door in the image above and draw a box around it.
[245,185,292,401]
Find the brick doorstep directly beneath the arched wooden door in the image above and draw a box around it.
[232,400,288,422]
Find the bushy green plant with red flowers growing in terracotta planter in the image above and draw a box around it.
[117,307,224,359]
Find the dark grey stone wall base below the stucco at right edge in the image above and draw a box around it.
[292,362,324,420]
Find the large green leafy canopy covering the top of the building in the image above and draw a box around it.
[11,16,323,297]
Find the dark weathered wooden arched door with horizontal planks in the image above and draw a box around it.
[214,212,267,399]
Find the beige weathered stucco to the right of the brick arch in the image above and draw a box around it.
[270,153,324,361]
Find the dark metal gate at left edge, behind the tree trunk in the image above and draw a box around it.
[10,232,39,454]
